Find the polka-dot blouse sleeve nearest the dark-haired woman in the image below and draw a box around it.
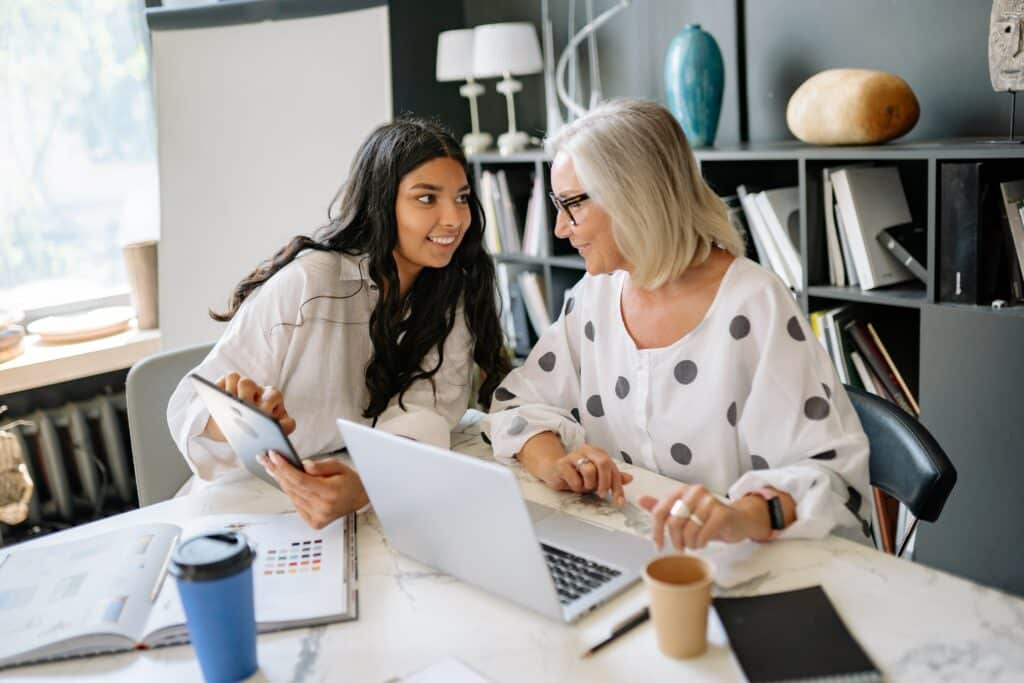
[483,276,589,463]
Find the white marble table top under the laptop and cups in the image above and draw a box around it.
[8,426,1024,683]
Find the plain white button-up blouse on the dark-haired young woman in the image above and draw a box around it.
[167,251,473,480]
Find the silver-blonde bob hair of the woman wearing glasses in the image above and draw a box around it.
[549,99,745,289]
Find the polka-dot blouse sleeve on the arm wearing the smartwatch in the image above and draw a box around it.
[729,285,871,538]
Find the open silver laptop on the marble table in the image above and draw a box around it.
[338,420,655,622]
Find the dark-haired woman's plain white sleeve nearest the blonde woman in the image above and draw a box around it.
[376,305,473,449]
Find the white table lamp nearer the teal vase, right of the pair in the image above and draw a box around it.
[473,22,544,155]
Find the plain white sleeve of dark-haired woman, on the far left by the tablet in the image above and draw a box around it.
[167,261,306,481]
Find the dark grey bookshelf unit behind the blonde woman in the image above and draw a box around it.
[470,140,1024,594]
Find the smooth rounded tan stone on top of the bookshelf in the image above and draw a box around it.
[785,69,921,144]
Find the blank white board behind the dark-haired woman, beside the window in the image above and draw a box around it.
[153,7,392,349]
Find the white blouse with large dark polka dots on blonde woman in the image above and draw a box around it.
[484,258,871,538]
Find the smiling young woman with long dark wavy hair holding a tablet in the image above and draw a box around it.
[168,119,510,527]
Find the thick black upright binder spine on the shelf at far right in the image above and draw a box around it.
[938,163,981,304]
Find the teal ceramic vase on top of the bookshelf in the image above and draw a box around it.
[665,24,725,147]
